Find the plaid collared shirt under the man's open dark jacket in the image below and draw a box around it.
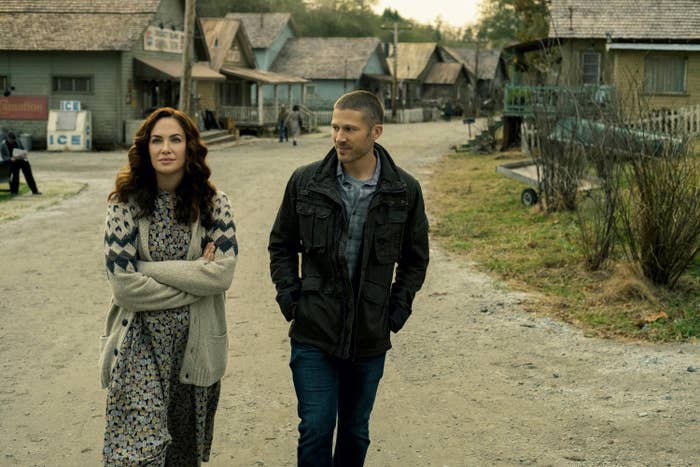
[336,153,382,280]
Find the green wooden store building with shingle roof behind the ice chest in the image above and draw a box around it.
[0,0,224,147]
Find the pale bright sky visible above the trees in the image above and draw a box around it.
[376,0,481,28]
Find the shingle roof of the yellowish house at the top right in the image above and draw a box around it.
[549,0,700,40]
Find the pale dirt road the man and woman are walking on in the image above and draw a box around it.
[0,121,700,467]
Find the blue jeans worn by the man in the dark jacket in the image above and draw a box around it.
[289,340,386,467]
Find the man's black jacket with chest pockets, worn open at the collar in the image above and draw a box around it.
[268,143,428,359]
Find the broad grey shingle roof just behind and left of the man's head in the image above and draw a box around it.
[270,37,389,79]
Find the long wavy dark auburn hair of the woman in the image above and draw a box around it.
[109,107,216,227]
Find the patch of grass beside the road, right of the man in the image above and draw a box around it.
[427,151,700,341]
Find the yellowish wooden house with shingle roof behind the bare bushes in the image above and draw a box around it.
[504,0,700,117]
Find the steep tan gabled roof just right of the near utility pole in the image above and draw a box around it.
[199,18,255,70]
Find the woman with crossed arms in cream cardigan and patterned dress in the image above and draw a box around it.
[100,107,238,466]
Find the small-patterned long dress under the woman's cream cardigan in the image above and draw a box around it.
[103,192,221,467]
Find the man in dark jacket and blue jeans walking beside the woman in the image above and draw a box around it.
[268,91,428,467]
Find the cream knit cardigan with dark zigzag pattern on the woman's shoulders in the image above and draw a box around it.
[99,192,238,388]
